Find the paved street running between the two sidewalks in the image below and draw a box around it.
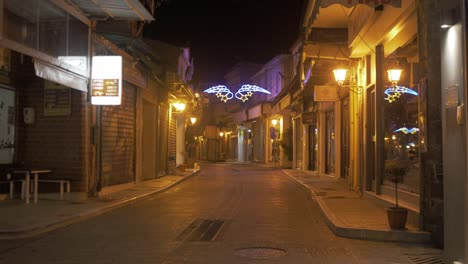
[0,164,440,264]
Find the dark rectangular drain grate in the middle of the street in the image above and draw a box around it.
[176,218,226,241]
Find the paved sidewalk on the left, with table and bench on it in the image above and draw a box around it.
[0,171,198,239]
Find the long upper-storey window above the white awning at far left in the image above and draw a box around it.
[2,0,89,74]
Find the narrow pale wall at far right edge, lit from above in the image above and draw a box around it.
[441,24,468,263]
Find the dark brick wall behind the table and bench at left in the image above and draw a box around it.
[12,52,87,191]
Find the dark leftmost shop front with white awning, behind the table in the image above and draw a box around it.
[0,1,91,196]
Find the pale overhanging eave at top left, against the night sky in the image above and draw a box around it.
[70,0,154,21]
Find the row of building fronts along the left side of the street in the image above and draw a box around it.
[0,0,195,198]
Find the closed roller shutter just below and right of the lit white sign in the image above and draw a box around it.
[101,83,136,187]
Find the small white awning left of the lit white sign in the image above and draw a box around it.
[34,59,88,92]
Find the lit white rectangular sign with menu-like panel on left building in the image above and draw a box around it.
[91,56,122,105]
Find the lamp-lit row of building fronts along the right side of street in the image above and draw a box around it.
[300,0,467,263]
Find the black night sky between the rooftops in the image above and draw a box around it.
[144,0,305,85]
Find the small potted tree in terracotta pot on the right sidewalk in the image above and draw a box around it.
[385,160,411,229]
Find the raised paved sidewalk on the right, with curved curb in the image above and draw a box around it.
[282,169,431,243]
